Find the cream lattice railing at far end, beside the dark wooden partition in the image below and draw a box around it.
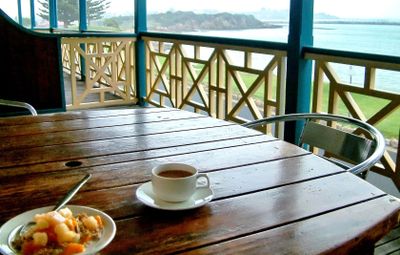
[62,37,137,109]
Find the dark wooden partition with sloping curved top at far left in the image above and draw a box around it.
[0,9,65,116]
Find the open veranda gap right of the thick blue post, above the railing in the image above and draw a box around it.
[313,0,400,56]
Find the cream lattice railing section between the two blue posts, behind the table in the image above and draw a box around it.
[143,34,286,134]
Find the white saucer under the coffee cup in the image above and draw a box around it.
[136,182,214,211]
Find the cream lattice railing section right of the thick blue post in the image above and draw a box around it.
[305,49,400,188]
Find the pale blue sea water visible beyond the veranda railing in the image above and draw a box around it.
[191,24,400,93]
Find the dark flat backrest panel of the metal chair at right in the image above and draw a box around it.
[300,121,373,164]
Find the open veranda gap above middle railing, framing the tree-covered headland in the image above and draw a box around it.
[147,0,289,42]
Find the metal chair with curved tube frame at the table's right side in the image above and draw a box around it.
[242,113,385,177]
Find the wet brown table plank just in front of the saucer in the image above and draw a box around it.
[101,173,385,254]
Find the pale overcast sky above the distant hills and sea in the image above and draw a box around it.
[0,0,400,19]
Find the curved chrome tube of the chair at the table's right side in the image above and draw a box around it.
[242,113,385,174]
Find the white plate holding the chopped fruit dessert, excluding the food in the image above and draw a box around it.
[0,205,117,255]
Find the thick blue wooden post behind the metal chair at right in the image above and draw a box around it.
[285,0,314,143]
